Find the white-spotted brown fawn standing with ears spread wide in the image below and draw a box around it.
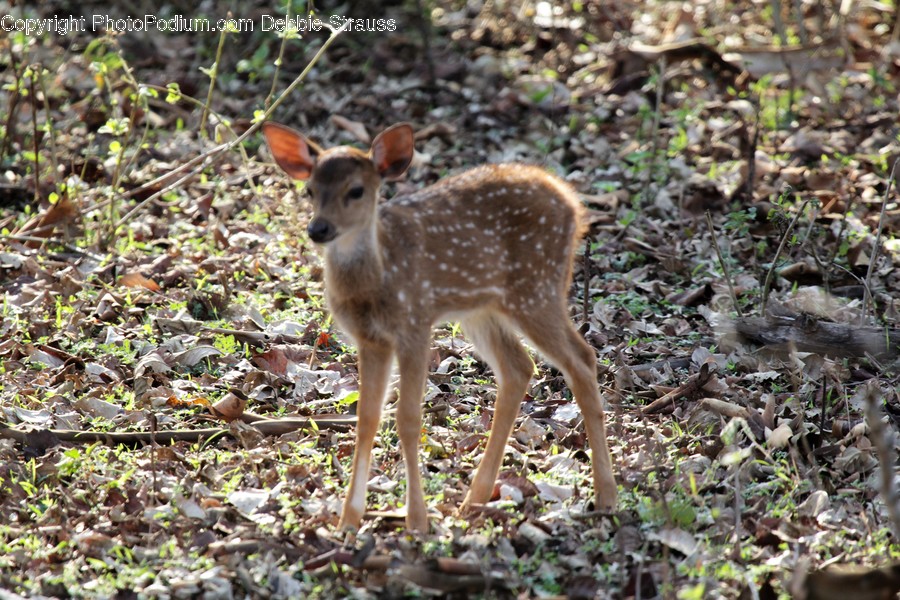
[262,121,617,532]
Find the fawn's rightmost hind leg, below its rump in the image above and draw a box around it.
[516,306,617,512]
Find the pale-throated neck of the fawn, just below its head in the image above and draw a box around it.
[325,221,384,297]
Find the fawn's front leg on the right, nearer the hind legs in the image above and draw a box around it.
[397,342,428,532]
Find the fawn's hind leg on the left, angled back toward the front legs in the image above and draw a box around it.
[462,313,534,510]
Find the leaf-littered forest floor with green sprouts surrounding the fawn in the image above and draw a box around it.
[0,0,900,598]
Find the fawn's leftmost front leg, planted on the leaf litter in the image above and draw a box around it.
[338,342,392,529]
